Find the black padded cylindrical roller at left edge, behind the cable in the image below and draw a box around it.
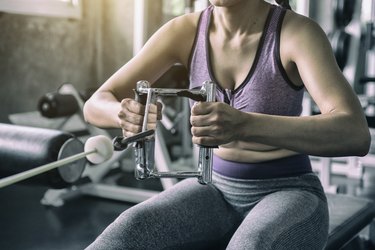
[0,124,85,188]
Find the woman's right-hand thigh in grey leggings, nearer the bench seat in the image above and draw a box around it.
[228,190,328,250]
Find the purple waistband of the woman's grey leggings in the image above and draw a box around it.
[213,154,312,179]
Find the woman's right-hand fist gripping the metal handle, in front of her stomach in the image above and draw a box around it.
[190,102,245,146]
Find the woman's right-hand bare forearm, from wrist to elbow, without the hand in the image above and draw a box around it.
[240,112,371,157]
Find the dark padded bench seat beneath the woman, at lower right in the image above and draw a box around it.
[325,194,375,250]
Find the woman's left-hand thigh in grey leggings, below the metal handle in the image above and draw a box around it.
[87,179,240,249]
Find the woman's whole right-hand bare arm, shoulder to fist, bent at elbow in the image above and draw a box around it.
[191,14,370,156]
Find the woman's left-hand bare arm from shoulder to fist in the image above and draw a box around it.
[84,14,197,133]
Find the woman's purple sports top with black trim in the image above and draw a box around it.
[189,5,304,116]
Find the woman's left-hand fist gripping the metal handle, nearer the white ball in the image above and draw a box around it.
[118,98,162,137]
